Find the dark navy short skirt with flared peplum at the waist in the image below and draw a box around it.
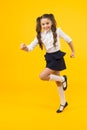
[44,50,66,71]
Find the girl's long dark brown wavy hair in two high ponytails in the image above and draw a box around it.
[36,14,57,49]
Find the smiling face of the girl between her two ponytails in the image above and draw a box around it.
[41,18,52,32]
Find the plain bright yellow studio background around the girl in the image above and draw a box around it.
[0,0,87,130]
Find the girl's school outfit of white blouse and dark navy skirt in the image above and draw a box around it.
[27,28,72,71]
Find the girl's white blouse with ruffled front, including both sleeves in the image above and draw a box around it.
[27,28,72,53]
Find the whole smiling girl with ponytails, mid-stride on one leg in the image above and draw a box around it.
[20,14,75,113]
